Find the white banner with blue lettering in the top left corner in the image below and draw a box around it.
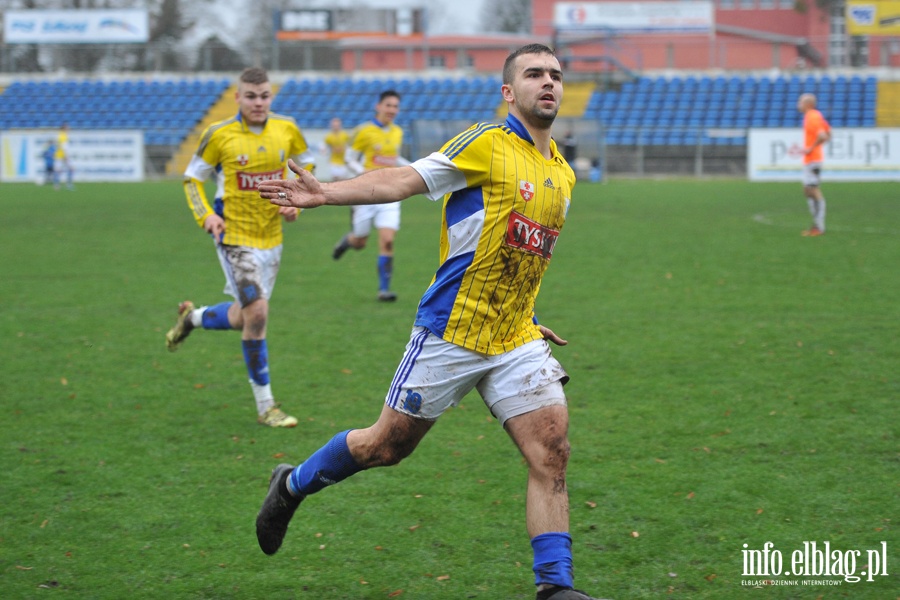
[3,9,150,44]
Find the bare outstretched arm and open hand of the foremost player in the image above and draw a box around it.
[258,160,428,208]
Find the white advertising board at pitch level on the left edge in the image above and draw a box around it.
[0,129,144,182]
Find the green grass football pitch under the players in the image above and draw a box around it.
[0,180,900,600]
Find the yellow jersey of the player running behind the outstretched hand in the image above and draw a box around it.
[184,113,314,249]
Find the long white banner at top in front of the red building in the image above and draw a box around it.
[553,0,715,34]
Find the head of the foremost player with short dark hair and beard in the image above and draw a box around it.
[501,54,563,129]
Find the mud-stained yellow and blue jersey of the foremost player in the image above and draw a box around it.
[413,115,575,355]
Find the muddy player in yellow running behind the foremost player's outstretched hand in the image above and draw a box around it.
[166,67,314,427]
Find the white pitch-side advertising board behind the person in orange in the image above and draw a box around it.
[747,128,900,182]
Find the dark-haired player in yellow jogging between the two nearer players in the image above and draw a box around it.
[332,90,409,302]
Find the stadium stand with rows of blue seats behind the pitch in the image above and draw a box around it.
[0,74,884,162]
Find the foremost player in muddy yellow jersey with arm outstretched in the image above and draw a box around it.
[256,44,591,600]
